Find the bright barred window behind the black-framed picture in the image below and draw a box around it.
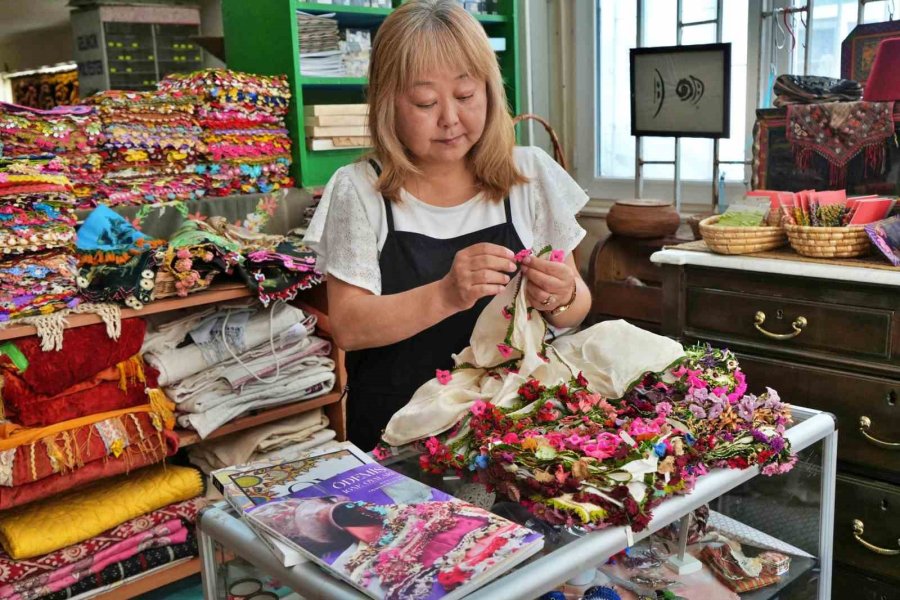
[574,0,891,210]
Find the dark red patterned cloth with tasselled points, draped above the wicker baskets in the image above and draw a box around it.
[786,102,894,187]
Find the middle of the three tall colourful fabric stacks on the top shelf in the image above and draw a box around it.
[85,90,205,205]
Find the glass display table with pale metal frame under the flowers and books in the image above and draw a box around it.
[198,407,837,600]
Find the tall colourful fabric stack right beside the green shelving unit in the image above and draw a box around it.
[159,69,293,196]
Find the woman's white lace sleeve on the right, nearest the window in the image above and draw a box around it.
[530,148,588,252]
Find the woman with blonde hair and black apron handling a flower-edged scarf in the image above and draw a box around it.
[307,0,591,450]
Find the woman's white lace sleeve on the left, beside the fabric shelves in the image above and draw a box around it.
[304,171,381,294]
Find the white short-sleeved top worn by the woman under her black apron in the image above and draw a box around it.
[305,147,588,294]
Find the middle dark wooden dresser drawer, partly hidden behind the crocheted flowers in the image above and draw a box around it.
[738,354,900,483]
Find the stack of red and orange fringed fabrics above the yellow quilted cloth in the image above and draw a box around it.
[0,319,178,510]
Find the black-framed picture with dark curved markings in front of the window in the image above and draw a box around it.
[631,44,731,138]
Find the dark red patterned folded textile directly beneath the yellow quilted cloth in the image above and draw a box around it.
[0,496,207,597]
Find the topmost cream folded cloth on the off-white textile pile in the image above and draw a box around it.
[144,304,306,386]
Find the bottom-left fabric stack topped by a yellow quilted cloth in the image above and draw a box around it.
[0,466,206,600]
